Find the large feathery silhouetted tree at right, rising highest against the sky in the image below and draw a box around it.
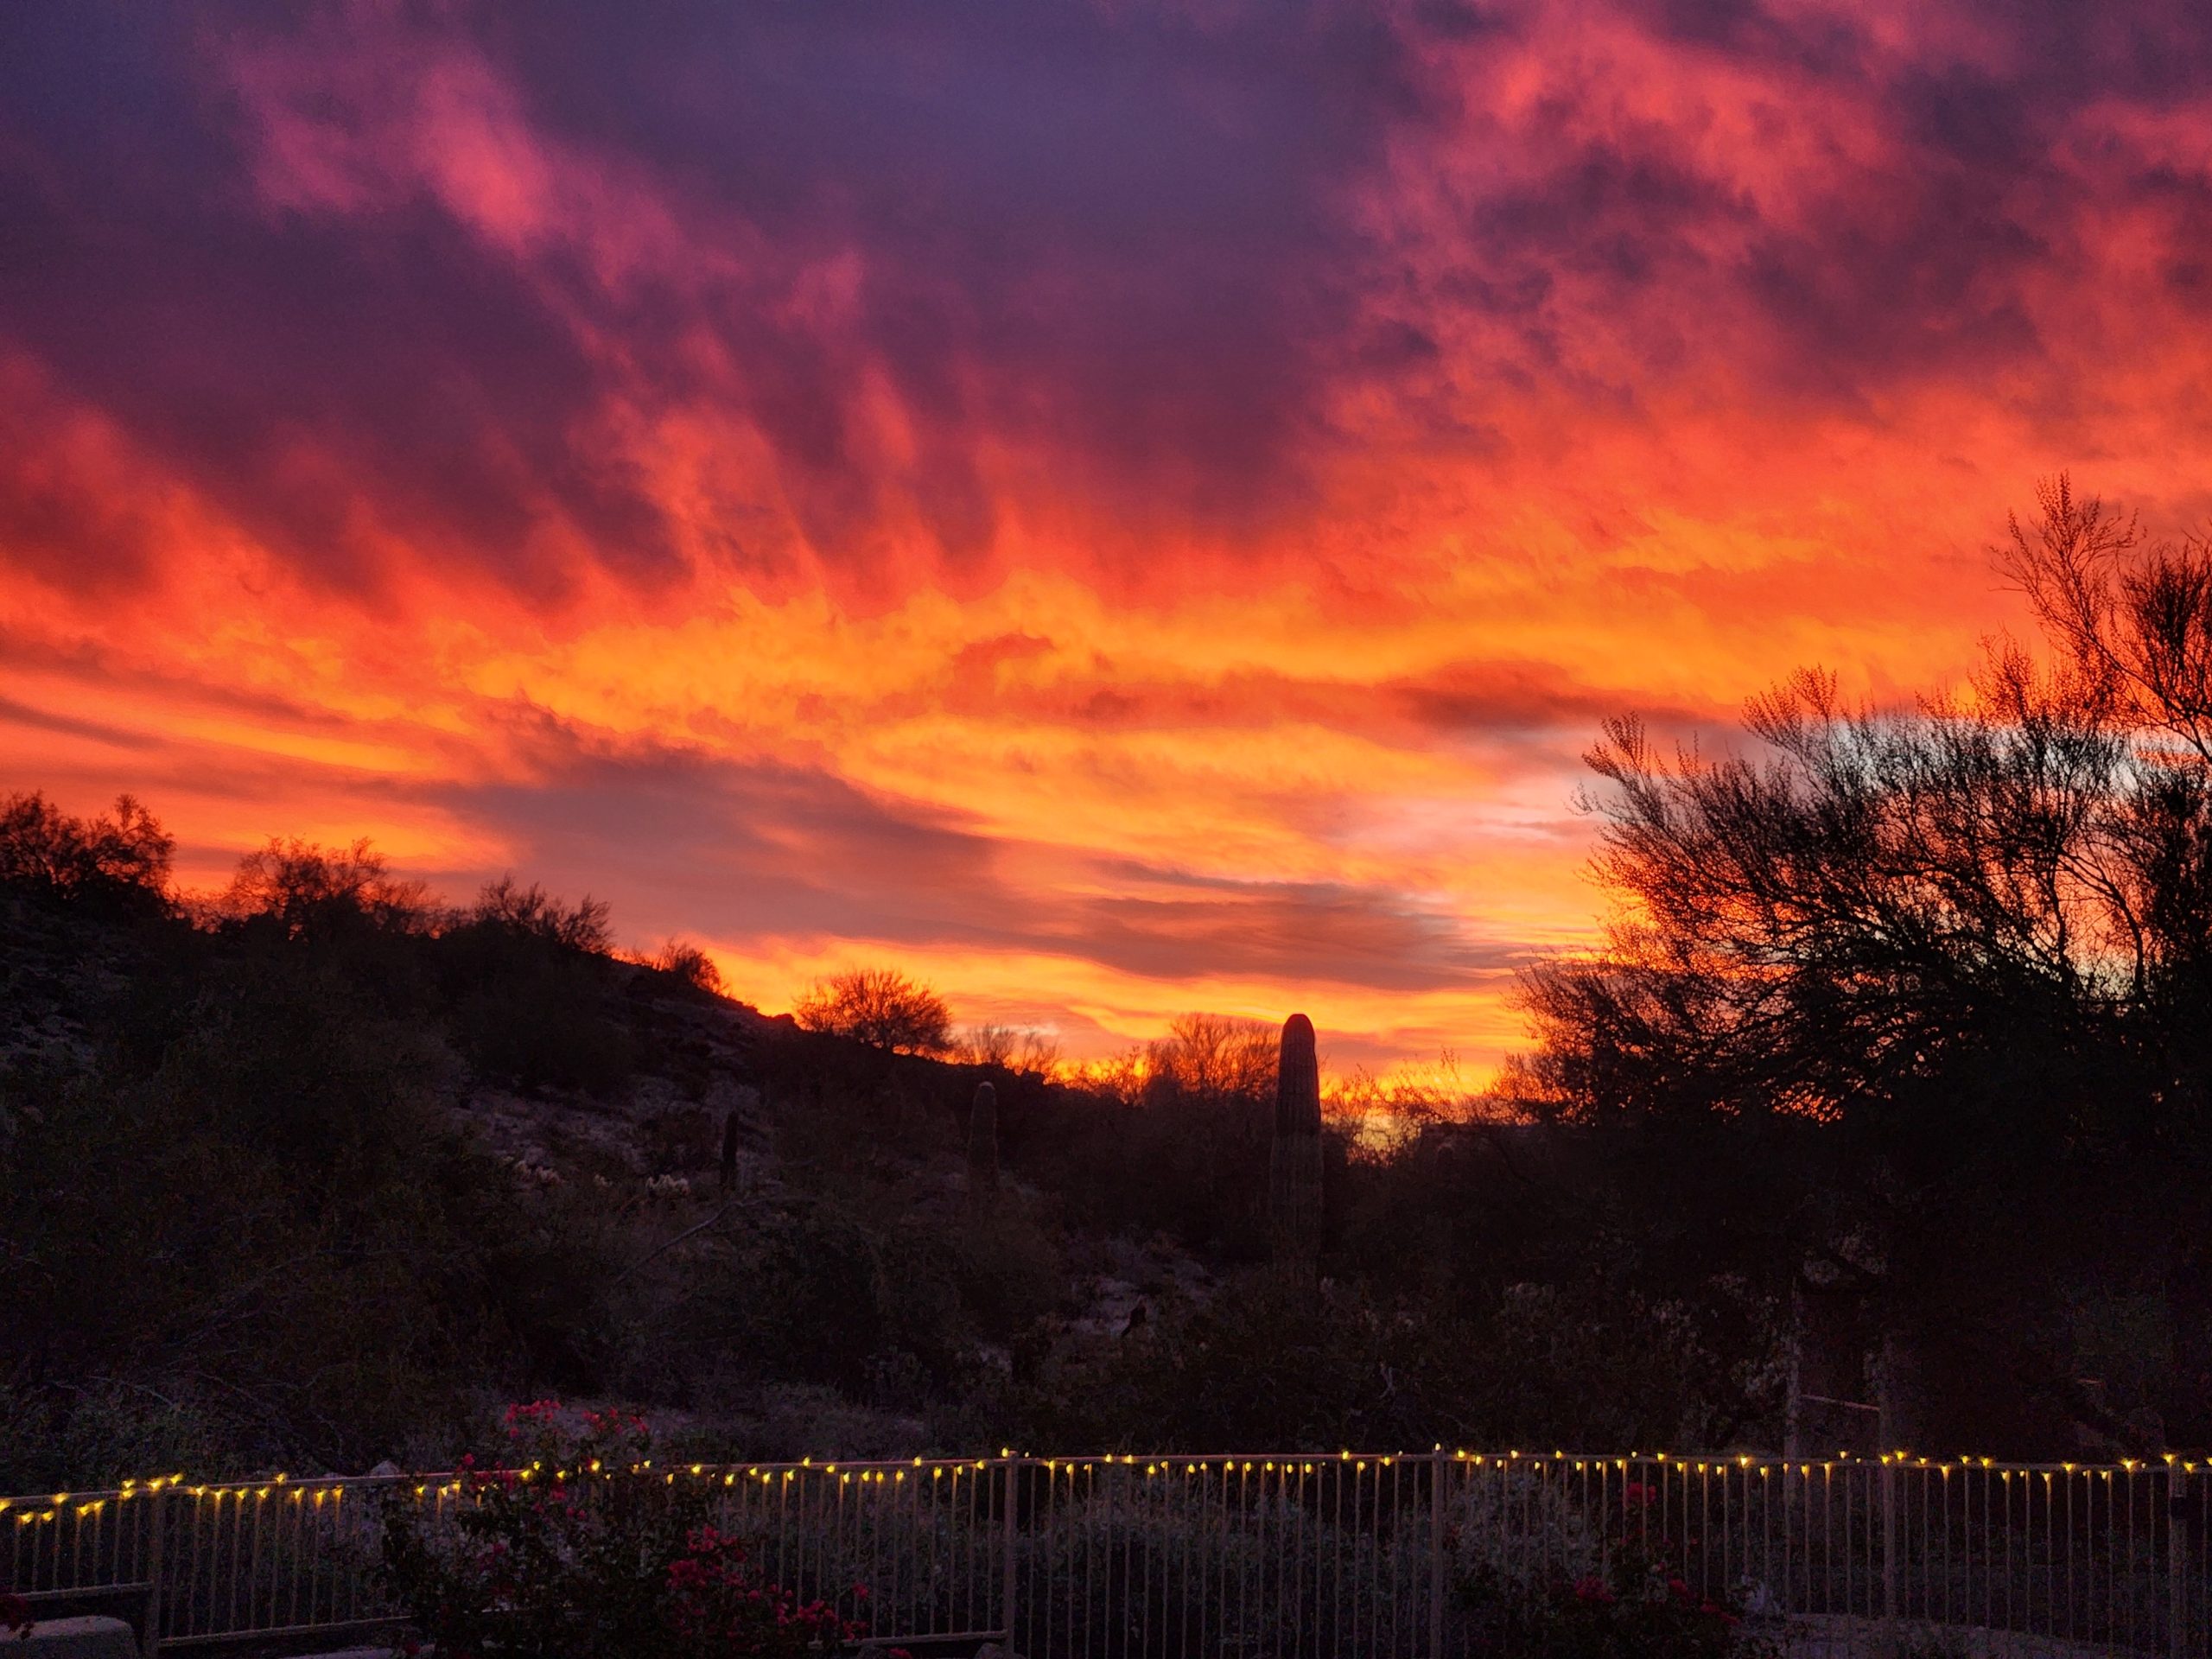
[1506,480,2212,1433]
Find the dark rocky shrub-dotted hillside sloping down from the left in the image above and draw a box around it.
[0,825,1214,1484]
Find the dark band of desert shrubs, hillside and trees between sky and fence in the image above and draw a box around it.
[0,489,2212,1491]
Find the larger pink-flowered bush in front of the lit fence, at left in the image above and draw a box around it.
[383,1400,868,1659]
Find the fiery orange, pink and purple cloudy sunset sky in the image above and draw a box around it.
[0,0,2212,1073]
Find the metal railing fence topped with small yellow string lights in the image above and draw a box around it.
[0,1451,2212,1659]
